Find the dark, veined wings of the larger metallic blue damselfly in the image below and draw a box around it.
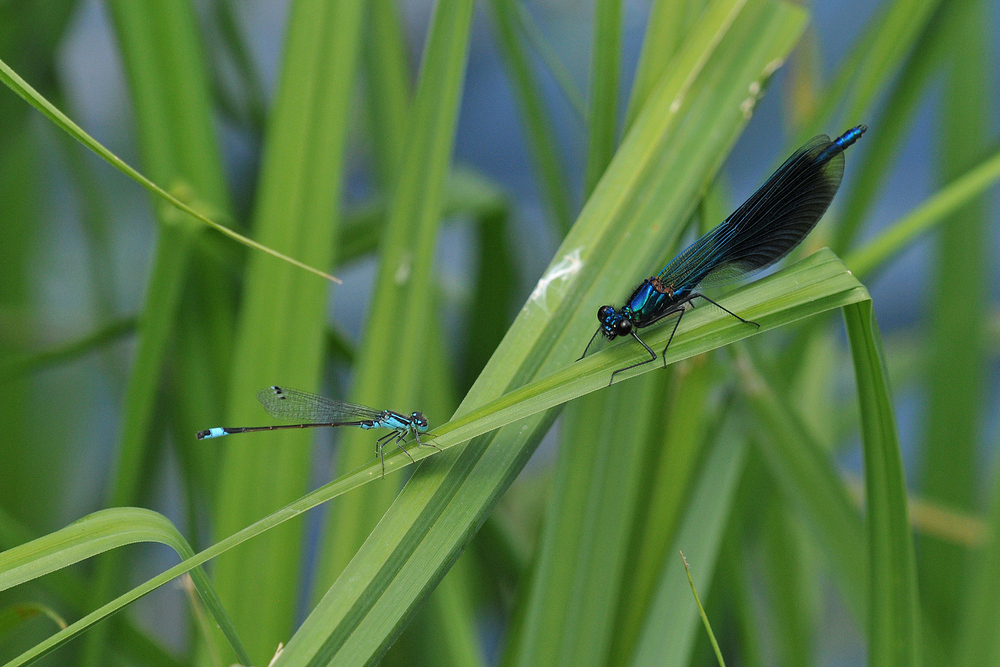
[659,135,844,289]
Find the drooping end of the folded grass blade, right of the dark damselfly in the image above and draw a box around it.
[844,301,922,667]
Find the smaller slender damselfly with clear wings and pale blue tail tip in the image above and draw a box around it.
[197,387,440,477]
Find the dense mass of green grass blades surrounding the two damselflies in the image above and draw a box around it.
[0,0,1000,667]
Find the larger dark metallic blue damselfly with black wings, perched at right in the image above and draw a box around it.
[580,125,868,385]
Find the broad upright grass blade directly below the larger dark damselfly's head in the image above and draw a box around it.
[505,375,659,665]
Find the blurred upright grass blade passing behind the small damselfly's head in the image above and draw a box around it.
[314,0,472,599]
